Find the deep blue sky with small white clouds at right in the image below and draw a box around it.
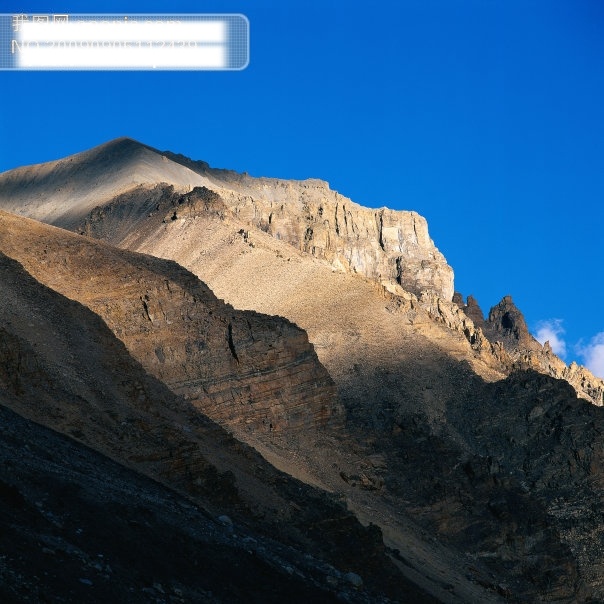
[0,0,604,376]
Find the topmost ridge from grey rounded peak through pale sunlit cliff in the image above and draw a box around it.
[0,139,453,300]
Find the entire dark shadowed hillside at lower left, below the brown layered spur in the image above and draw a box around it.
[0,239,431,602]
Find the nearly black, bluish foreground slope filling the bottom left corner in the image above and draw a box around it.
[0,396,358,603]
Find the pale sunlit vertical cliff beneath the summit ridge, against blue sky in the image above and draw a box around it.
[217,177,453,300]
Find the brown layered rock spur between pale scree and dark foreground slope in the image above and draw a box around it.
[0,213,342,433]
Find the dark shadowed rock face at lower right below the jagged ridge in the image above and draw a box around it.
[387,368,604,602]
